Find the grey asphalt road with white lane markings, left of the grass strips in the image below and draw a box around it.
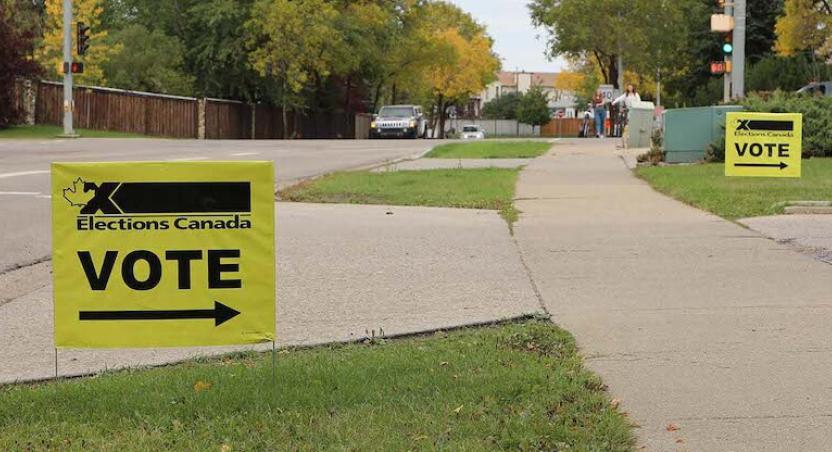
[0,138,439,274]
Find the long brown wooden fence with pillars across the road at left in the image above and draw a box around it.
[22,81,360,139]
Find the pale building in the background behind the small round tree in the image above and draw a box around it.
[469,72,576,118]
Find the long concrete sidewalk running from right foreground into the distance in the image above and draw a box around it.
[515,140,832,451]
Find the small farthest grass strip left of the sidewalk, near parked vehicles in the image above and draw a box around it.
[425,140,552,159]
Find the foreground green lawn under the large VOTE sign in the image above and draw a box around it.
[0,320,634,451]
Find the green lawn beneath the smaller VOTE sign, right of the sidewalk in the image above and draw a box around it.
[637,159,832,220]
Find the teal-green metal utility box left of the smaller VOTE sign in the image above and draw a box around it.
[664,105,743,163]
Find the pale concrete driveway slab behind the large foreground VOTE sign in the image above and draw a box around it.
[0,203,541,383]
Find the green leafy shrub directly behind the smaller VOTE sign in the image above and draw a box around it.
[740,91,832,157]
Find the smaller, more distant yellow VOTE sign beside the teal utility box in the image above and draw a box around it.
[725,112,803,177]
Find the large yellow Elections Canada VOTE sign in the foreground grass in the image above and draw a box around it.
[52,162,275,348]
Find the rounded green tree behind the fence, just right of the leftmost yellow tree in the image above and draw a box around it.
[103,24,193,96]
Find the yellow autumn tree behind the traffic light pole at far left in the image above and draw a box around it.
[35,0,122,85]
